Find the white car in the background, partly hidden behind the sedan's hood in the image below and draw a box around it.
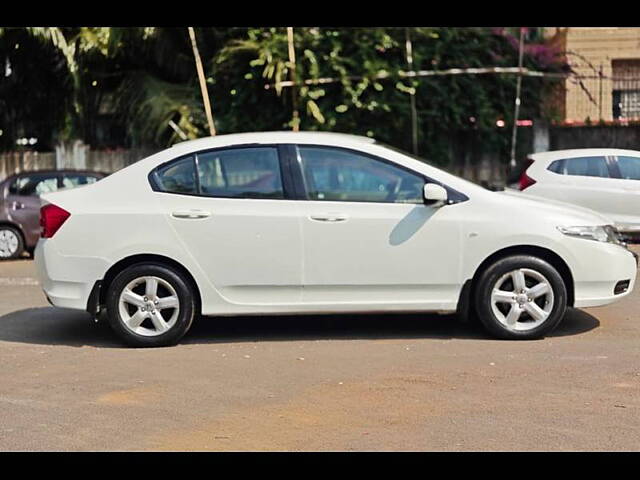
[519,148,640,242]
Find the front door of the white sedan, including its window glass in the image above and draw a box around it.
[295,145,462,310]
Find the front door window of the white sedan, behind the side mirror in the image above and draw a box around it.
[298,146,425,203]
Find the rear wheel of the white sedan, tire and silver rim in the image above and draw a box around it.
[107,263,196,347]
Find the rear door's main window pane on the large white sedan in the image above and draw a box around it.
[198,147,284,198]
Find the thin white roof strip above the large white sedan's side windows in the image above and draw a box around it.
[173,131,375,150]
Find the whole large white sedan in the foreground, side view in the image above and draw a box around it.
[35,132,637,346]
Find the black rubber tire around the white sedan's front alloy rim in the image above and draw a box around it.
[474,255,567,340]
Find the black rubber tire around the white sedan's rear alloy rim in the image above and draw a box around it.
[106,263,196,347]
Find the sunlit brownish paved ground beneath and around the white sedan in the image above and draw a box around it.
[0,253,640,451]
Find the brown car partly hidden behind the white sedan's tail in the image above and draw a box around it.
[0,170,105,260]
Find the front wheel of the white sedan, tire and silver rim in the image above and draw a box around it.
[475,255,567,340]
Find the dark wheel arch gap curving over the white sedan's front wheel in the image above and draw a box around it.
[457,245,574,319]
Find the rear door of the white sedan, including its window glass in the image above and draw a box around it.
[154,146,302,305]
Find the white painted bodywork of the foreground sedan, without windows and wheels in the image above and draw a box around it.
[35,132,637,324]
